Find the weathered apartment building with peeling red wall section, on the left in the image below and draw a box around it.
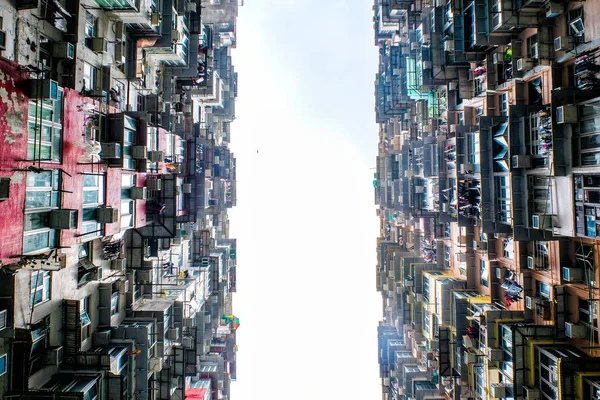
[0,0,242,400]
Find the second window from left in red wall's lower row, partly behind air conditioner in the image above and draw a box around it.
[81,174,105,240]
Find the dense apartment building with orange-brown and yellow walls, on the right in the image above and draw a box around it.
[373,0,600,400]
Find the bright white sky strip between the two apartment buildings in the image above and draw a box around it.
[230,0,381,400]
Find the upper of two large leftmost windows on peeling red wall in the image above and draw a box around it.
[27,92,63,162]
